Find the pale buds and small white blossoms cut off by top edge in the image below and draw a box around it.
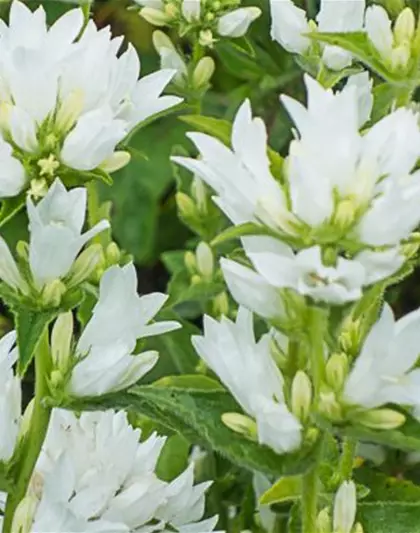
[135,0,261,47]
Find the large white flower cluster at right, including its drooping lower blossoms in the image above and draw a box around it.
[174,73,420,308]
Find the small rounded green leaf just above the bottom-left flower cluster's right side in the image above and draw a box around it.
[156,435,191,482]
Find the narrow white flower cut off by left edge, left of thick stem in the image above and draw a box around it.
[0,331,22,461]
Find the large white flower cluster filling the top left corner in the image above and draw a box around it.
[0,0,180,198]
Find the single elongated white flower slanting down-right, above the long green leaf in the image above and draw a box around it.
[192,308,301,453]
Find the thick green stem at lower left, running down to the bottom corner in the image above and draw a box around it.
[3,328,51,533]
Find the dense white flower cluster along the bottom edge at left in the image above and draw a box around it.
[11,410,218,533]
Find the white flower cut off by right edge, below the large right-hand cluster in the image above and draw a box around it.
[344,304,420,409]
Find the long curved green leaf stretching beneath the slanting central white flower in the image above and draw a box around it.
[70,386,320,476]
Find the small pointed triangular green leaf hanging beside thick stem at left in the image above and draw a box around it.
[15,309,58,376]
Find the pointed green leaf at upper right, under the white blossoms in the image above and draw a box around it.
[308,32,404,84]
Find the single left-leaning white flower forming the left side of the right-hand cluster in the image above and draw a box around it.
[173,100,291,233]
